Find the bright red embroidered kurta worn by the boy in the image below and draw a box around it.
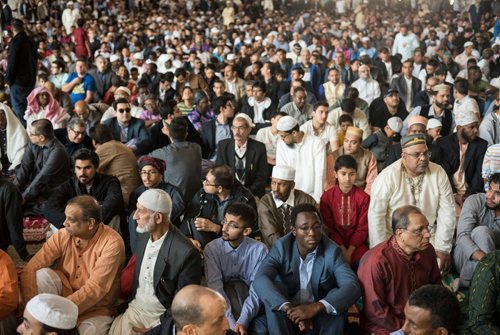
[319,185,370,264]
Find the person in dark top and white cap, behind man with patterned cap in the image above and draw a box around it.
[362,116,403,172]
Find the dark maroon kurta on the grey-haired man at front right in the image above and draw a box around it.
[358,236,441,335]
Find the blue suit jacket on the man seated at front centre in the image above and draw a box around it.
[253,233,361,313]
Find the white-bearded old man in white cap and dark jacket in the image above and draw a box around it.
[109,189,201,335]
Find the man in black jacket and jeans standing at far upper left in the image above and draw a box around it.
[5,19,38,127]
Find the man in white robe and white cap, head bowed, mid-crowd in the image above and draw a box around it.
[276,115,326,202]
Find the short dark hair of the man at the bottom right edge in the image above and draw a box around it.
[408,285,461,334]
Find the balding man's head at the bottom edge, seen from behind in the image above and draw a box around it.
[146,285,230,335]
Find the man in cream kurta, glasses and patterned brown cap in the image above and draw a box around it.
[368,134,456,276]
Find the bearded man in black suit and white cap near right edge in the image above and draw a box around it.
[437,111,488,207]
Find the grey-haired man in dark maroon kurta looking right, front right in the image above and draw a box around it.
[358,205,441,334]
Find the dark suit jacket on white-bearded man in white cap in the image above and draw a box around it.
[132,225,202,313]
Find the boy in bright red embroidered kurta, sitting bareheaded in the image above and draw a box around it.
[319,155,370,269]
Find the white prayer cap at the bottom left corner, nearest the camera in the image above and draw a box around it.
[26,293,78,329]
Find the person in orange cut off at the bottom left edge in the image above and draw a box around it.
[0,250,19,334]
